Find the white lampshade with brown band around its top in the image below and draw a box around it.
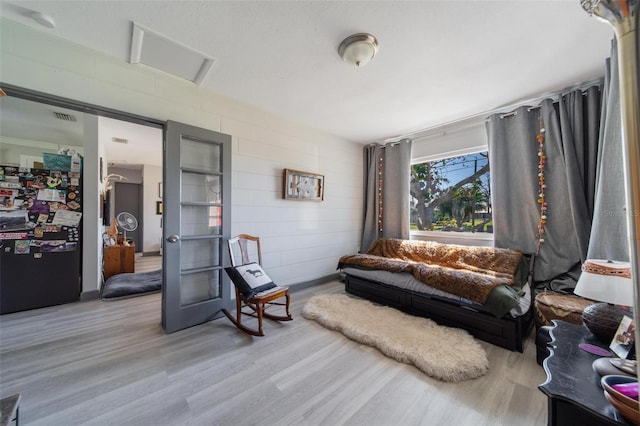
[574,259,634,306]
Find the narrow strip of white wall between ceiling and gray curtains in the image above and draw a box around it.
[382,77,604,143]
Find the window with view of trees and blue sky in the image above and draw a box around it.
[409,151,493,233]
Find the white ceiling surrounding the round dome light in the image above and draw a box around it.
[0,0,613,142]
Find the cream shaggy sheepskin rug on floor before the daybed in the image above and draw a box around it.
[302,294,489,382]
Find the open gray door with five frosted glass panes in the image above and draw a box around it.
[162,121,231,333]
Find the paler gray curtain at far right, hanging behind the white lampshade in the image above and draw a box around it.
[587,39,629,262]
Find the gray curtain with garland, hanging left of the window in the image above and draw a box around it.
[360,139,411,253]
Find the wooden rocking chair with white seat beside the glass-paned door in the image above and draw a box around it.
[222,234,293,336]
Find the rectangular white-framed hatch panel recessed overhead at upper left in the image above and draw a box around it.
[129,22,214,85]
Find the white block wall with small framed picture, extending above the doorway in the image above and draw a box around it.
[0,18,362,291]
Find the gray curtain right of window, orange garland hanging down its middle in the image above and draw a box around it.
[487,86,601,291]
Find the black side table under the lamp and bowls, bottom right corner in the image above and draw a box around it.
[536,320,631,426]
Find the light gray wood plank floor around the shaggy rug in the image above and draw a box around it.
[0,282,546,426]
